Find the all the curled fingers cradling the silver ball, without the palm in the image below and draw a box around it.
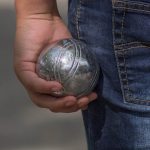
[16,64,97,113]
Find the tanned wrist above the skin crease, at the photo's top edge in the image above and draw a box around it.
[15,0,60,20]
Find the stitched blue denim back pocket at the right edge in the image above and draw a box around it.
[113,0,150,106]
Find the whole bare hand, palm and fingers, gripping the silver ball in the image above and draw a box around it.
[14,14,97,112]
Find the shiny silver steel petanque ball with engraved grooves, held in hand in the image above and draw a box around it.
[36,39,100,97]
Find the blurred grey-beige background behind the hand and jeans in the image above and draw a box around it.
[0,0,87,150]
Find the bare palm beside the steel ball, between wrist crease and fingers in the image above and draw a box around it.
[15,19,71,87]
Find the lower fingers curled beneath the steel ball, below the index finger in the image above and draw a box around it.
[29,93,97,113]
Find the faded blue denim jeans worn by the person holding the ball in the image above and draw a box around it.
[68,0,150,150]
